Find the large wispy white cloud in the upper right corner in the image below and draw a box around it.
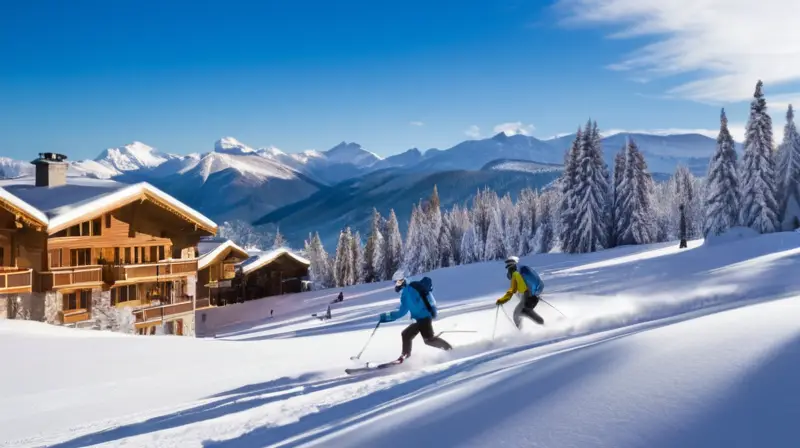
[558,0,800,109]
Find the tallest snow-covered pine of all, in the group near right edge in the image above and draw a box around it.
[741,80,779,233]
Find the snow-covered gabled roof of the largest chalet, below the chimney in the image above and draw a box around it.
[0,176,217,233]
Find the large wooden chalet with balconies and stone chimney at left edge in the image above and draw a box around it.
[0,153,217,334]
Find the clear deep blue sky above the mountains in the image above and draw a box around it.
[0,0,800,159]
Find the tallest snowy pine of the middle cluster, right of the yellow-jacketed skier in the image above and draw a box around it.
[568,121,609,253]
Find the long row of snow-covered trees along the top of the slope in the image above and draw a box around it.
[290,81,800,288]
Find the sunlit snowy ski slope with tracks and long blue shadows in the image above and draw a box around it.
[0,233,800,448]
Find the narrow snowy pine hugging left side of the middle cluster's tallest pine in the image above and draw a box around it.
[559,128,584,253]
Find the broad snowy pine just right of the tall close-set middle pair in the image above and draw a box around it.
[620,139,656,244]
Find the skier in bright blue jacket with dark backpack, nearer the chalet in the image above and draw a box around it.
[379,271,453,362]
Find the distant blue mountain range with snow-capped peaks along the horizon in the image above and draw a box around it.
[0,133,715,228]
